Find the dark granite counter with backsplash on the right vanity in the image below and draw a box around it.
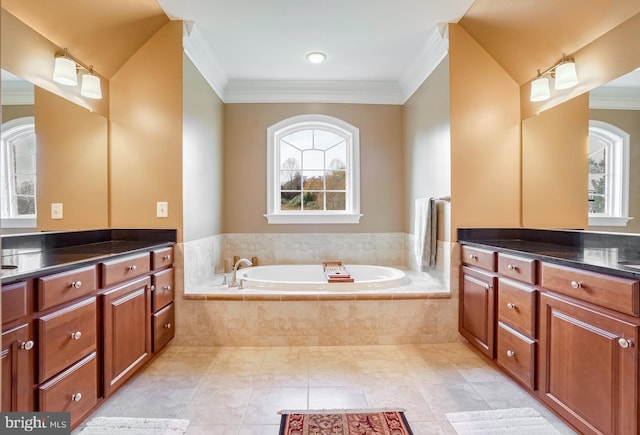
[458,228,640,279]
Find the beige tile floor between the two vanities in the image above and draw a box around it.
[74,343,574,435]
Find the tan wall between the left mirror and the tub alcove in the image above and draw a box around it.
[109,21,182,241]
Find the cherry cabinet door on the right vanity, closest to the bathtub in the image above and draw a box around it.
[458,267,498,358]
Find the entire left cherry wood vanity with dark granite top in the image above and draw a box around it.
[1,230,176,427]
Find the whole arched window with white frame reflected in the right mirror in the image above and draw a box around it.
[589,121,632,226]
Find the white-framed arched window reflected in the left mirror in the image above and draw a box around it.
[0,116,37,228]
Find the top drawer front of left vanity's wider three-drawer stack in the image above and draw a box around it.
[38,266,98,310]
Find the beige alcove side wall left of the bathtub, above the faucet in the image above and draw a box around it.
[182,56,224,242]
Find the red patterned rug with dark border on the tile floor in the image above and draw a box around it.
[278,409,413,435]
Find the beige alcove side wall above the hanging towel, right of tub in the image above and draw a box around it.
[402,58,451,240]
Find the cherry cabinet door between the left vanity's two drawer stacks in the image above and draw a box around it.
[101,277,151,397]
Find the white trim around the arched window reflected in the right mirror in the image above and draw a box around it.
[589,120,633,227]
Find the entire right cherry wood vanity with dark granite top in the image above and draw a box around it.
[458,229,640,434]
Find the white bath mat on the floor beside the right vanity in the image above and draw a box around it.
[446,408,560,435]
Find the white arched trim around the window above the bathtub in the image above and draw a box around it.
[264,114,362,224]
